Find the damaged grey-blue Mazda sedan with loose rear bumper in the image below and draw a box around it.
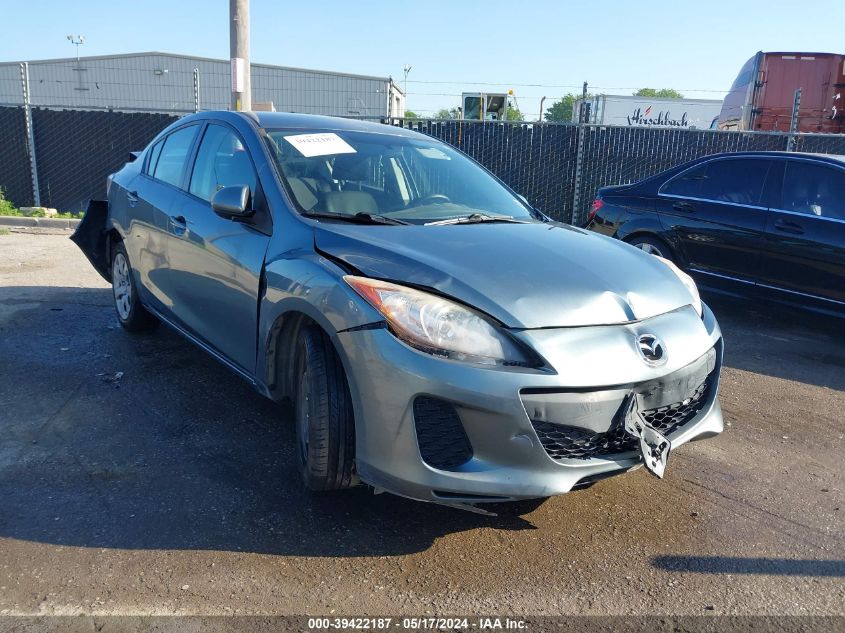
[73,112,723,512]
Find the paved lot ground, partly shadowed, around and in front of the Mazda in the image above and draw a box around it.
[0,231,845,615]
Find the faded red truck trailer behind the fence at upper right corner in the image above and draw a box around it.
[719,52,845,134]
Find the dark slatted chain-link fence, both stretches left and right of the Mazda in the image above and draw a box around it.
[0,107,845,224]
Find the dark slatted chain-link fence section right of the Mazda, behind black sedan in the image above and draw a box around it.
[384,119,845,224]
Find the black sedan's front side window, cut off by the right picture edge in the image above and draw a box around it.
[781,161,845,220]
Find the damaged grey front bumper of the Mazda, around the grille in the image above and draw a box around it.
[338,307,723,505]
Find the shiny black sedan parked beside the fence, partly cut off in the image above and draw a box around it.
[587,152,845,315]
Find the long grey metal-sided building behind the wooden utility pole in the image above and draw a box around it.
[0,53,405,117]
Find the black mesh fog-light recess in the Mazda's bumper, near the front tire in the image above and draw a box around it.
[414,396,472,470]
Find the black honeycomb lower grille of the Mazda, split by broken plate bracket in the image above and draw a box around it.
[531,377,710,459]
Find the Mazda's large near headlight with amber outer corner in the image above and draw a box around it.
[343,275,530,366]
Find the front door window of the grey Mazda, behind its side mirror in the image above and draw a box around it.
[190,124,257,202]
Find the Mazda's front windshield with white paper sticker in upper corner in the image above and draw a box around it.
[267,130,534,225]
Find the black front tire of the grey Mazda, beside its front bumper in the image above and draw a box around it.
[295,326,355,491]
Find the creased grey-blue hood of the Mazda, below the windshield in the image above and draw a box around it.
[315,223,691,329]
